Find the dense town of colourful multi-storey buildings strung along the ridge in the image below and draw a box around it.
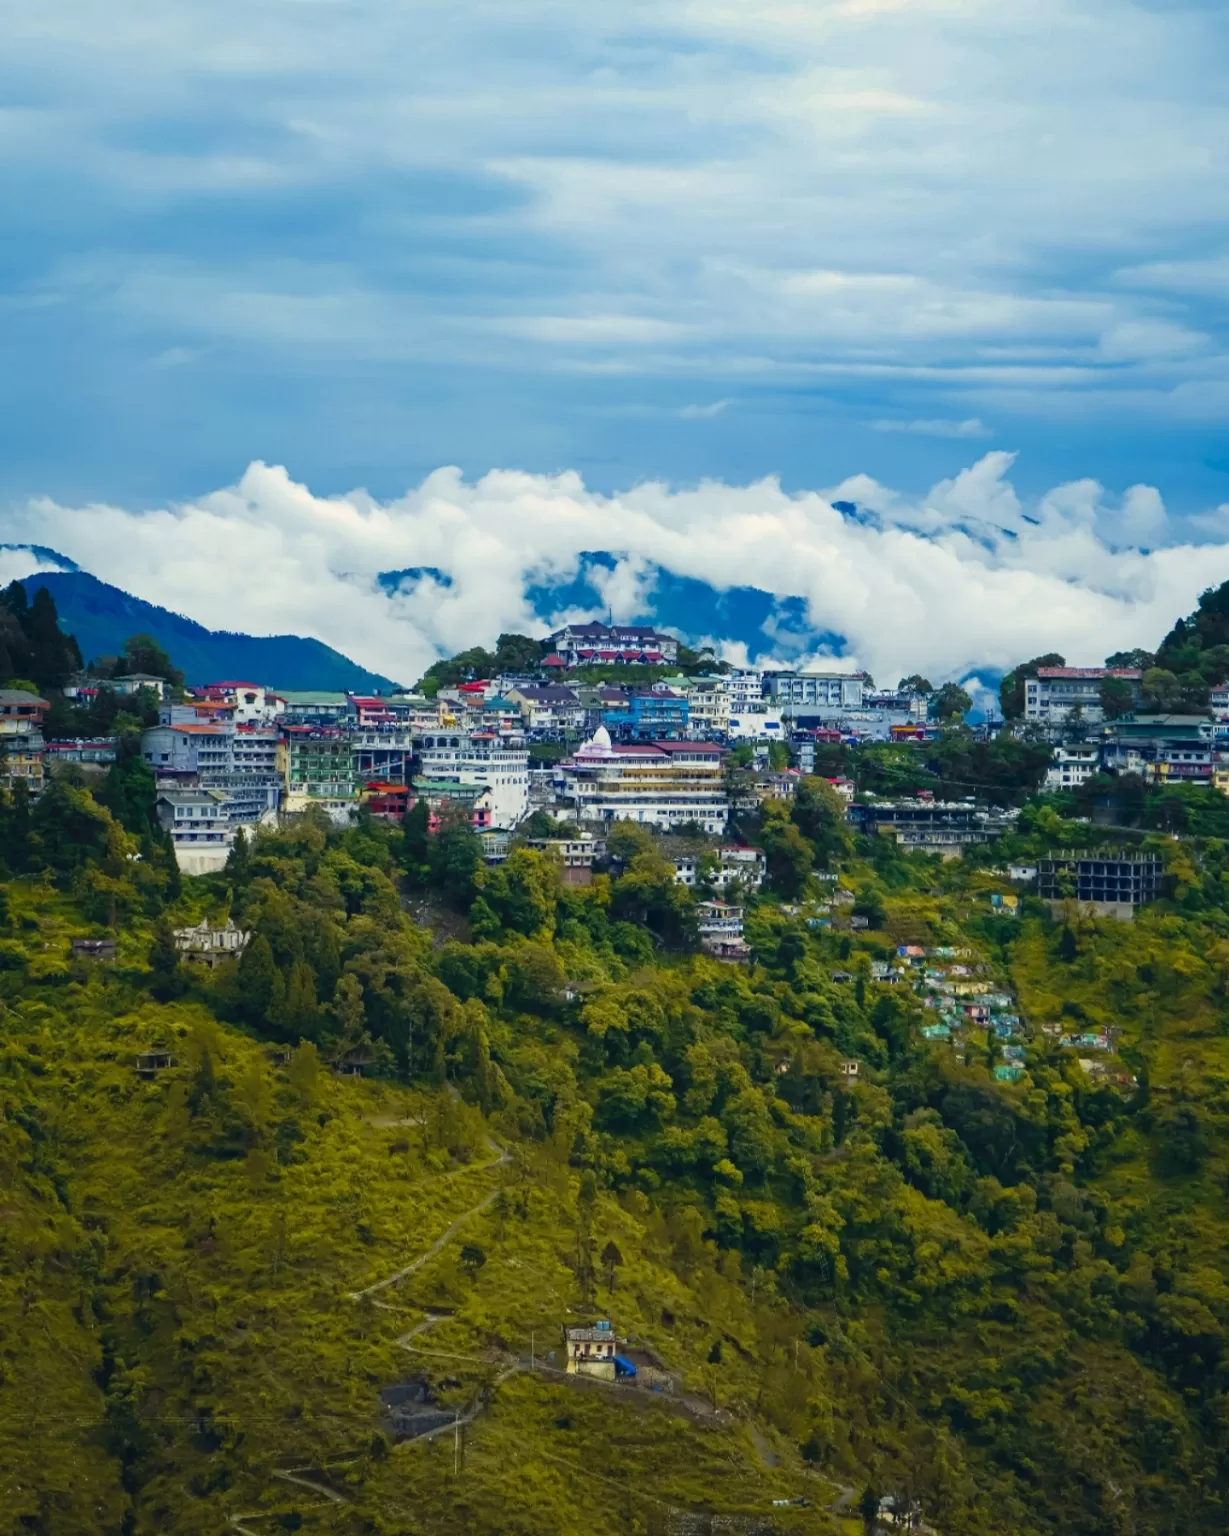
[0,622,1229,909]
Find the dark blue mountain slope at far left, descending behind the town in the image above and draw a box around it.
[22,568,398,693]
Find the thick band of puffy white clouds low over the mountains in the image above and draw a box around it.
[6,452,1229,682]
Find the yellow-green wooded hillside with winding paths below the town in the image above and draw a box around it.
[0,779,1229,1536]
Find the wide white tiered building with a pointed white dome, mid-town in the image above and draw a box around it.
[555,727,730,834]
